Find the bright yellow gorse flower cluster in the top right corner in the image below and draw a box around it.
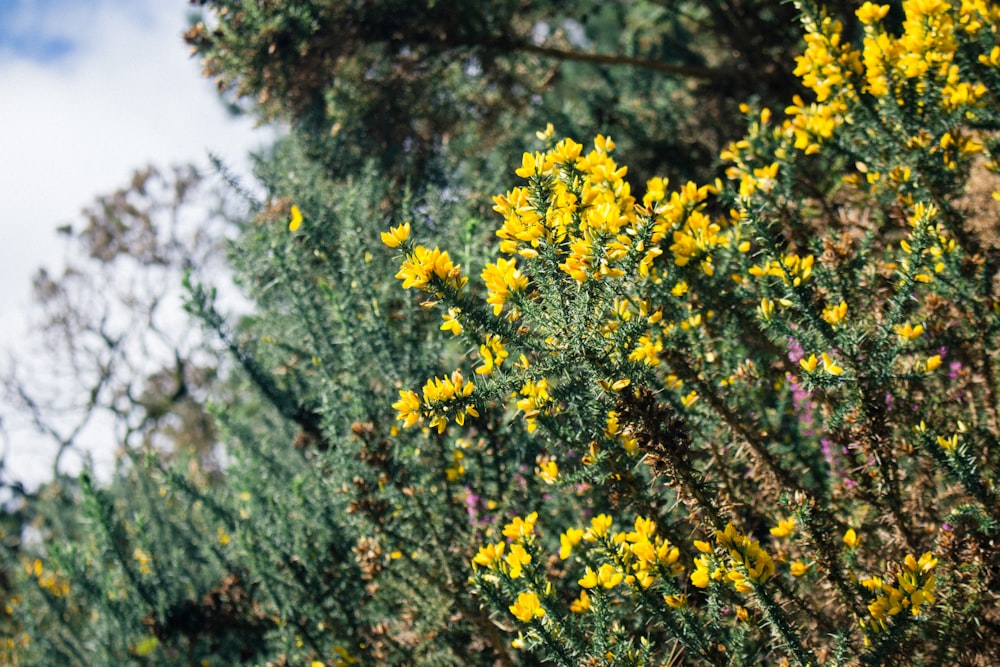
[722,0,1000,175]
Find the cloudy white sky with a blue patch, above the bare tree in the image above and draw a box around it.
[0,0,272,488]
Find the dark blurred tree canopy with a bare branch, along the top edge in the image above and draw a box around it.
[186,0,812,189]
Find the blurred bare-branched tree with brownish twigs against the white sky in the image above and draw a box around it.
[3,167,236,486]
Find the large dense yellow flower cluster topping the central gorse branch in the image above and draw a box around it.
[483,135,728,290]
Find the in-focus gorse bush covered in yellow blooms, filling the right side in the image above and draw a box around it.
[383,1,1000,665]
